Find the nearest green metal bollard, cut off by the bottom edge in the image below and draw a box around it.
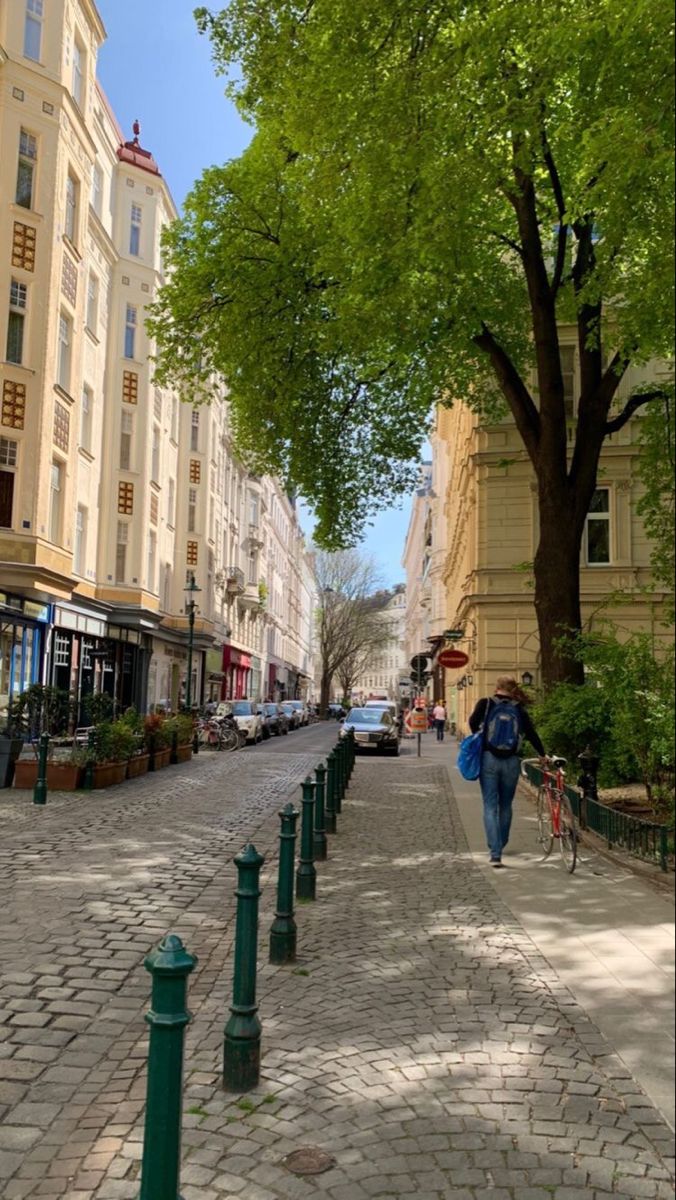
[139,934,197,1200]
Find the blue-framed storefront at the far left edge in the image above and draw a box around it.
[0,592,52,721]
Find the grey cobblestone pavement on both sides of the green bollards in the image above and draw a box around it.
[0,730,674,1200]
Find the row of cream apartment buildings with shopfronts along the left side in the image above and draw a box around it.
[0,0,313,710]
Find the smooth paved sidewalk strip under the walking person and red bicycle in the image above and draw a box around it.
[437,738,676,1127]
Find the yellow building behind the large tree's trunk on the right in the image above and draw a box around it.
[431,348,664,730]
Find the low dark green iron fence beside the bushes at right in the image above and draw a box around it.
[526,766,674,871]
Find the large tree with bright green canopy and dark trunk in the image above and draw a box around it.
[151,0,674,684]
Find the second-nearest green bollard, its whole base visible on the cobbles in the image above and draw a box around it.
[223,842,265,1092]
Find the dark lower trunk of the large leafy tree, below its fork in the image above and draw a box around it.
[534,494,585,690]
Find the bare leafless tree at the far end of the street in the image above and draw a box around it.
[315,550,389,714]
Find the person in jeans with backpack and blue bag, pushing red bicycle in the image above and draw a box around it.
[469,676,545,866]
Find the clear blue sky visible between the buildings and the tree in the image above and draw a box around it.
[96,0,411,587]
